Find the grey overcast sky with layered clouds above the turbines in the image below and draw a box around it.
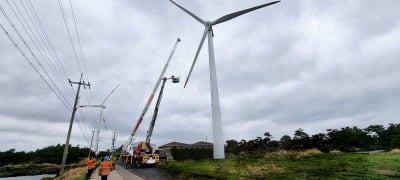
[0,0,400,151]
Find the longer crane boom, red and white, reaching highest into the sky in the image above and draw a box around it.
[124,38,181,150]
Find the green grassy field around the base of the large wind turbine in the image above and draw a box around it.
[159,150,400,180]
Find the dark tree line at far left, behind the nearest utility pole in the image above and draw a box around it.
[0,144,89,166]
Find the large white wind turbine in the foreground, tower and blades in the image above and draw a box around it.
[170,0,280,159]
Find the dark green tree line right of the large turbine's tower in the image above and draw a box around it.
[225,124,400,154]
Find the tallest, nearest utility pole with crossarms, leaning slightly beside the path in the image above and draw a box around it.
[60,73,90,176]
